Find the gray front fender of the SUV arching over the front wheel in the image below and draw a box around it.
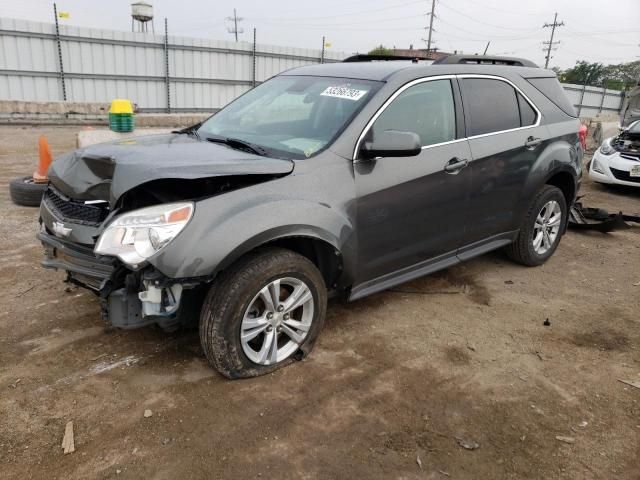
[149,185,356,278]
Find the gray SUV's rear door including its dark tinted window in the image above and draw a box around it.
[460,75,548,248]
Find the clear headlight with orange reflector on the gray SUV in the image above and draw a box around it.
[94,202,193,266]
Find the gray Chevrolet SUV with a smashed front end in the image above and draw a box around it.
[38,57,581,378]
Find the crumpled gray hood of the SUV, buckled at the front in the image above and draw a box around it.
[49,134,294,205]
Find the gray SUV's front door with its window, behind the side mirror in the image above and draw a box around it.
[355,78,470,283]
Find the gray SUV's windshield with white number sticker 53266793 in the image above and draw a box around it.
[198,76,380,158]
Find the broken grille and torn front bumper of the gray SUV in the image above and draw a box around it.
[38,186,208,331]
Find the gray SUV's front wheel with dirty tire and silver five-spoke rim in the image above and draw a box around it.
[200,248,327,379]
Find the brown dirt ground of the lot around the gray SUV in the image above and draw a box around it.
[0,127,640,479]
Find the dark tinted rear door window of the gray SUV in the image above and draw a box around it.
[462,78,520,136]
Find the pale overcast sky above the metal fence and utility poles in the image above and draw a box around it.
[0,0,640,68]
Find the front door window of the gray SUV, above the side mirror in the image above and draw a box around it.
[369,80,456,146]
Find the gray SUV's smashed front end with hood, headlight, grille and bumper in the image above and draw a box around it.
[38,135,293,330]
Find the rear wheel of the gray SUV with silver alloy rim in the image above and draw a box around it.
[506,185,568,267]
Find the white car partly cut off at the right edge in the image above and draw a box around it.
[589,120,640,187]
